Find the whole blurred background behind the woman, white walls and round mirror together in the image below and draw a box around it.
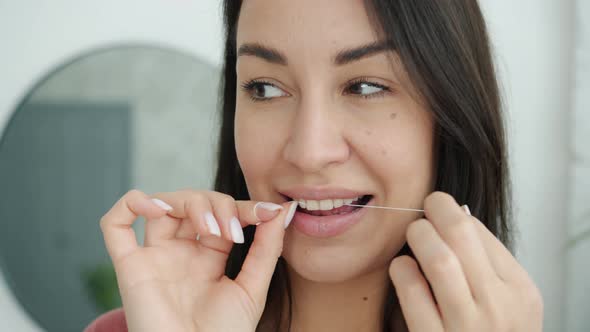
[0,0,590,332]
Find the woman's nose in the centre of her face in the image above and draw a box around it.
[283,92,350,173]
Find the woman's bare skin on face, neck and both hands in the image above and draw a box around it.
[100,0,543,332]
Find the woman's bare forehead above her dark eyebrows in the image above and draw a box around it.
[236,0,378,55]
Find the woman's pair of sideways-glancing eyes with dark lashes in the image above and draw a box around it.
[240,77,391,102]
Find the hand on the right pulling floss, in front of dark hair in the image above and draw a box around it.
[389,192,543,332]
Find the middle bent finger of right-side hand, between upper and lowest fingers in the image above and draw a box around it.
[406,219,474,321]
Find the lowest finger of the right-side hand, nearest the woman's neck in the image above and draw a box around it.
[389,256,443,332]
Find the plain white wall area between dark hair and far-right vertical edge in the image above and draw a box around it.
[481,0,574,332]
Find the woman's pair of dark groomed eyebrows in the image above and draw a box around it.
[238,41,395,66]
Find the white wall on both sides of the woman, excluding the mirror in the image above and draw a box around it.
[0,0,590,331]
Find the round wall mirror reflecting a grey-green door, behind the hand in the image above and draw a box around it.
[0,45,219,332]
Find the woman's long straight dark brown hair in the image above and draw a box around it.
[215,0,512,331]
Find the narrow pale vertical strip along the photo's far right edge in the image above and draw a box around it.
[565,0,590,331]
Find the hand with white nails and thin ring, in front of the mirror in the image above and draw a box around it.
[100,190,297,332]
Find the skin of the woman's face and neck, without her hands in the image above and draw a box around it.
[235,0,434,331]
